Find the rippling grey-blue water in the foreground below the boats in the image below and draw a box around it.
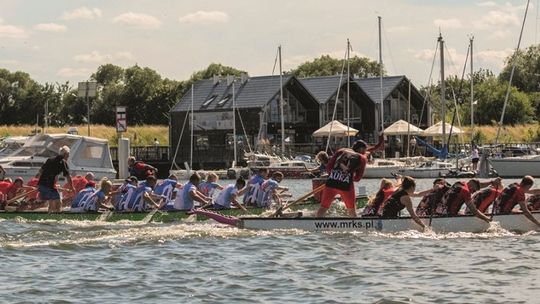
[0,180,540,303]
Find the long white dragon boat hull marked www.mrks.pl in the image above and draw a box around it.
[195,210,540,233]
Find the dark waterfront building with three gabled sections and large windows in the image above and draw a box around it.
[170,75,429,169]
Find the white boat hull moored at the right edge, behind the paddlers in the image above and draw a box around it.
[489,155,540,177]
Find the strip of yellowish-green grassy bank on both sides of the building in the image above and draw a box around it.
[0,124,540,146]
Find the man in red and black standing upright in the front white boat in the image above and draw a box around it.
[317,139,384,217]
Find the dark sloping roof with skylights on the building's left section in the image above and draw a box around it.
[171,75,295,112]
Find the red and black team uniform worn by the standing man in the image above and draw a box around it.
[321,149,367,209]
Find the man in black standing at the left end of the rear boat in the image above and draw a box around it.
[38,146,75,213]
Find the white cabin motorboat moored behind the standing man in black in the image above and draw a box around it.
[0,134,116,180]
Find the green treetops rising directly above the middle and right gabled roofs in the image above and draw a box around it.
[288,55,385,78]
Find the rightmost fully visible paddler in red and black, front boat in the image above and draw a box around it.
[493,175,540,226]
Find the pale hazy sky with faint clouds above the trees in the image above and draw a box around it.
[0,0,538,86]
